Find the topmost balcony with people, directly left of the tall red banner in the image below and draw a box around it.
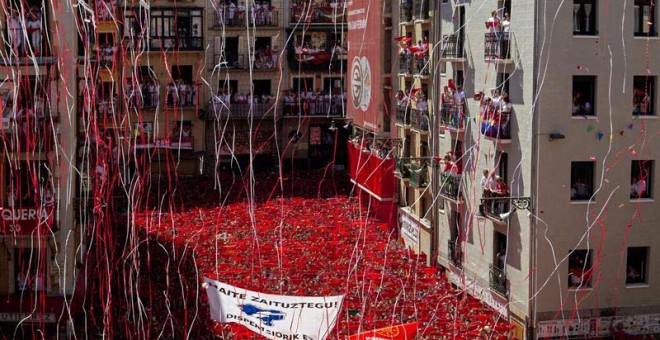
[289,0,346,26]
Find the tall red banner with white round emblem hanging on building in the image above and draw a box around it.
[346,0,382,132]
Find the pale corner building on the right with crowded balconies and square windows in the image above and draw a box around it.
[393,0,660,338]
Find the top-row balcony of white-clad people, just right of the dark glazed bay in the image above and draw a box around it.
[209,6,279,30]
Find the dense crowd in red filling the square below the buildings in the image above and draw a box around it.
[121,173,512,339]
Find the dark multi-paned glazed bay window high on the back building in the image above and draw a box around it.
[149,8,203,50]
